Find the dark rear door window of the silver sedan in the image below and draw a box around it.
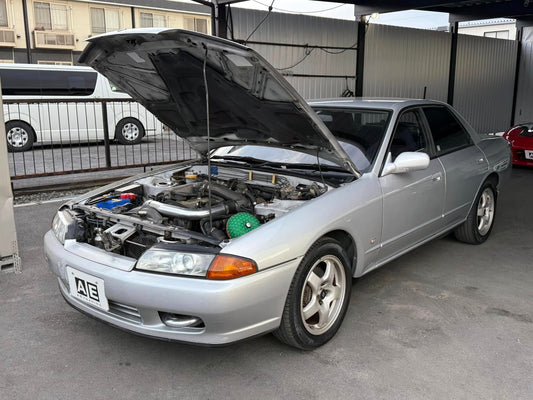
[423,107,472,155]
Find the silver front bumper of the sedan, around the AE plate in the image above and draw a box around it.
[44,231,301,345]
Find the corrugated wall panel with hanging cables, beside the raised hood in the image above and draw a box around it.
[228,8,357,99]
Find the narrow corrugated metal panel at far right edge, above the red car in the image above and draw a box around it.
[515,37,533,124]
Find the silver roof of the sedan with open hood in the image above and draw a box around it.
[309,97,445,110]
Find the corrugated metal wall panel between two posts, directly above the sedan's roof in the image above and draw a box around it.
[363,24,451,101]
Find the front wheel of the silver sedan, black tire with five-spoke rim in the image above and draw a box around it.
[274,238,352,350]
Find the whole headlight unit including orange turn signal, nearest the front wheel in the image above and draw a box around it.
[136,249,257,280]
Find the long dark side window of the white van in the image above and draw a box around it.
[0,69,97,96]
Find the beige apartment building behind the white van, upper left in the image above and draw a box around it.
[0,0,211,65]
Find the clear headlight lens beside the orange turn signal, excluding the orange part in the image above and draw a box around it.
[137,249,215,277]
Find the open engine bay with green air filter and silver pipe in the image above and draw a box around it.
[67,164,330,258]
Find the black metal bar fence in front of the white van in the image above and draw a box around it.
[4,99,196,179]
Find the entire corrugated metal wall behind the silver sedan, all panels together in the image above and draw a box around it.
[228,8,520,133]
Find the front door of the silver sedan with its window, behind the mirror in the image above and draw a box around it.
[379,109,445,259]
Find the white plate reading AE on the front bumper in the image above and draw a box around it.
[67,267,109,311]
